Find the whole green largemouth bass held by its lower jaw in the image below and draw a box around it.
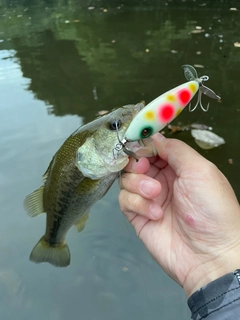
[24,103,155,267]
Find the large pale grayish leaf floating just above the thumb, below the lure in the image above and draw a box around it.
[191,129,225,150]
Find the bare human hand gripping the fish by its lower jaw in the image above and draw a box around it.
[119,134,240,296]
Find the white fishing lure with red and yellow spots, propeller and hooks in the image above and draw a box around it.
[114,65,221,159]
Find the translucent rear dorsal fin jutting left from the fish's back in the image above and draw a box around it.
[24,186,44,217]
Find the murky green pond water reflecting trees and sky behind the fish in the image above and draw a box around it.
[0,0,240,320]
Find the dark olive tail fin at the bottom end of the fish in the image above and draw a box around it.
[29,236,70,267]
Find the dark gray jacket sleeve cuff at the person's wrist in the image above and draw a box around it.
[188,269,240,320]
